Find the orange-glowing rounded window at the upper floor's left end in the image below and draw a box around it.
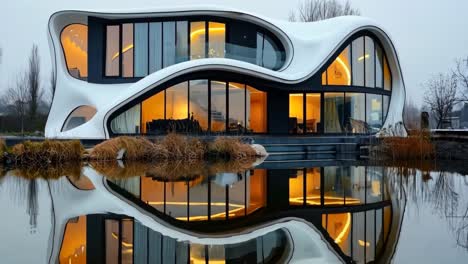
[60,24,88,79]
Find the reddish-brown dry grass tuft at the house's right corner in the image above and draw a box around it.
[371,131,436,161]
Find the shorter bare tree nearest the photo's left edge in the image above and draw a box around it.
[5,74,29,135]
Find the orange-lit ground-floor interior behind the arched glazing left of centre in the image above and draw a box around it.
[111,80,267,134]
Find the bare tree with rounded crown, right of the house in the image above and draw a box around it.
[424,73,459,128]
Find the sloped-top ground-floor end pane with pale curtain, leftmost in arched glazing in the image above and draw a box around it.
[111,104,140,134]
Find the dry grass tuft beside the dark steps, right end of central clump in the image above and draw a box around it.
[207,137,257,160]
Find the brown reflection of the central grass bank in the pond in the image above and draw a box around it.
[91,158,255,181]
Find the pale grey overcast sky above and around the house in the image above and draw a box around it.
[0,0,468,104]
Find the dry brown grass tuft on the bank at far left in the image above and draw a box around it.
[10,140,84,167]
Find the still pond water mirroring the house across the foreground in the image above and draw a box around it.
[0,162,468,263]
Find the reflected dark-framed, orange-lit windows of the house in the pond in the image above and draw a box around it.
[60,166,394,263]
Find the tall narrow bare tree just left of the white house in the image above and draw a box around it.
[26,44,42,119]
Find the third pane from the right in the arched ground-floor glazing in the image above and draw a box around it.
[211,81,227,131]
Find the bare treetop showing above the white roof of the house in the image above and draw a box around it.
[289,0,360,22]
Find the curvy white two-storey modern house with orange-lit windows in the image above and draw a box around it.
[45,6,406,139]
